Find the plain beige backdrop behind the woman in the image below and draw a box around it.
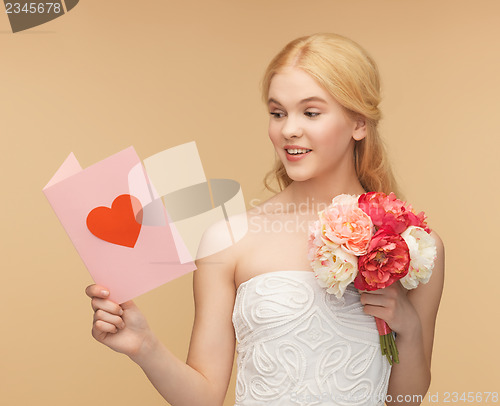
[0,0,500,406]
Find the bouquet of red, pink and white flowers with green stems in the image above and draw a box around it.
[308,192,437,365]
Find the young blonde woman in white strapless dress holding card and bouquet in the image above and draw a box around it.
[86,33,444,406]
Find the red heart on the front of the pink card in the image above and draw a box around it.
[87,194,142,248]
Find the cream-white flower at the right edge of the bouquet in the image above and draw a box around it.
[400,226,437,289]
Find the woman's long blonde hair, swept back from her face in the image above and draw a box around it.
[261,33,400,197]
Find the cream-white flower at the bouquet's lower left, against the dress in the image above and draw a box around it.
[311,246,358,299]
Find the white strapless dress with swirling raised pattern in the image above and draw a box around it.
[232,270,391,406]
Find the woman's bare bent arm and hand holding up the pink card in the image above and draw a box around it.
[86,232,236,406]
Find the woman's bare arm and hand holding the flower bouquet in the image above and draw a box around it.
[361,231,444,406]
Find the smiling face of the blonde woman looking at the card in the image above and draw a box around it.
[268,68,365,181]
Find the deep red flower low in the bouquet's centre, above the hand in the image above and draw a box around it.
[354,228,410,290]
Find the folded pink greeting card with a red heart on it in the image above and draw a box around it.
[43,147,196,303]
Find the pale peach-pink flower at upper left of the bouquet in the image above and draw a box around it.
[320,195,373,256]
